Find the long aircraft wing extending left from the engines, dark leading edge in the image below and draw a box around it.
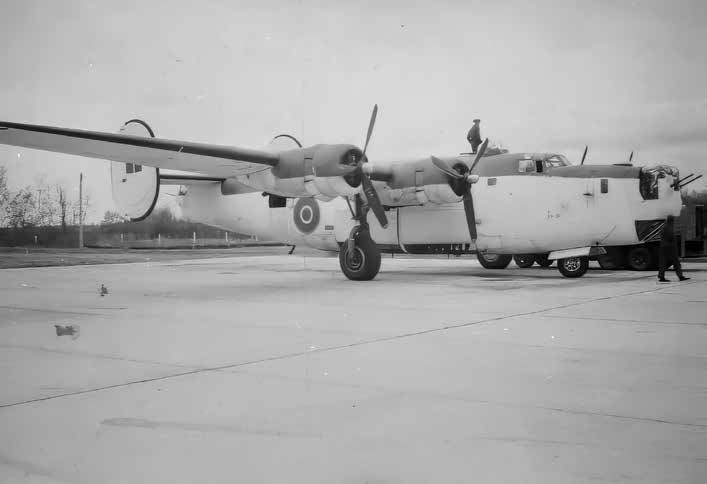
[0,121,279,178]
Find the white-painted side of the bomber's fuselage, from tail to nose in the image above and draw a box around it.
[180,175,681,254]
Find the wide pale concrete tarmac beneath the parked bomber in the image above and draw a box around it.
[0,254,707,484]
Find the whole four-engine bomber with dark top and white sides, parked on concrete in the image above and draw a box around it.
[0,106,681,280]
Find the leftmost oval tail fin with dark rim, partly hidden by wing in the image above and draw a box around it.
[110,119,160,221]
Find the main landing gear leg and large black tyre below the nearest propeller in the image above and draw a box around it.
[339,195,381,281]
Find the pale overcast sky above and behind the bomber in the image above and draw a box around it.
[0,0,707,220]
